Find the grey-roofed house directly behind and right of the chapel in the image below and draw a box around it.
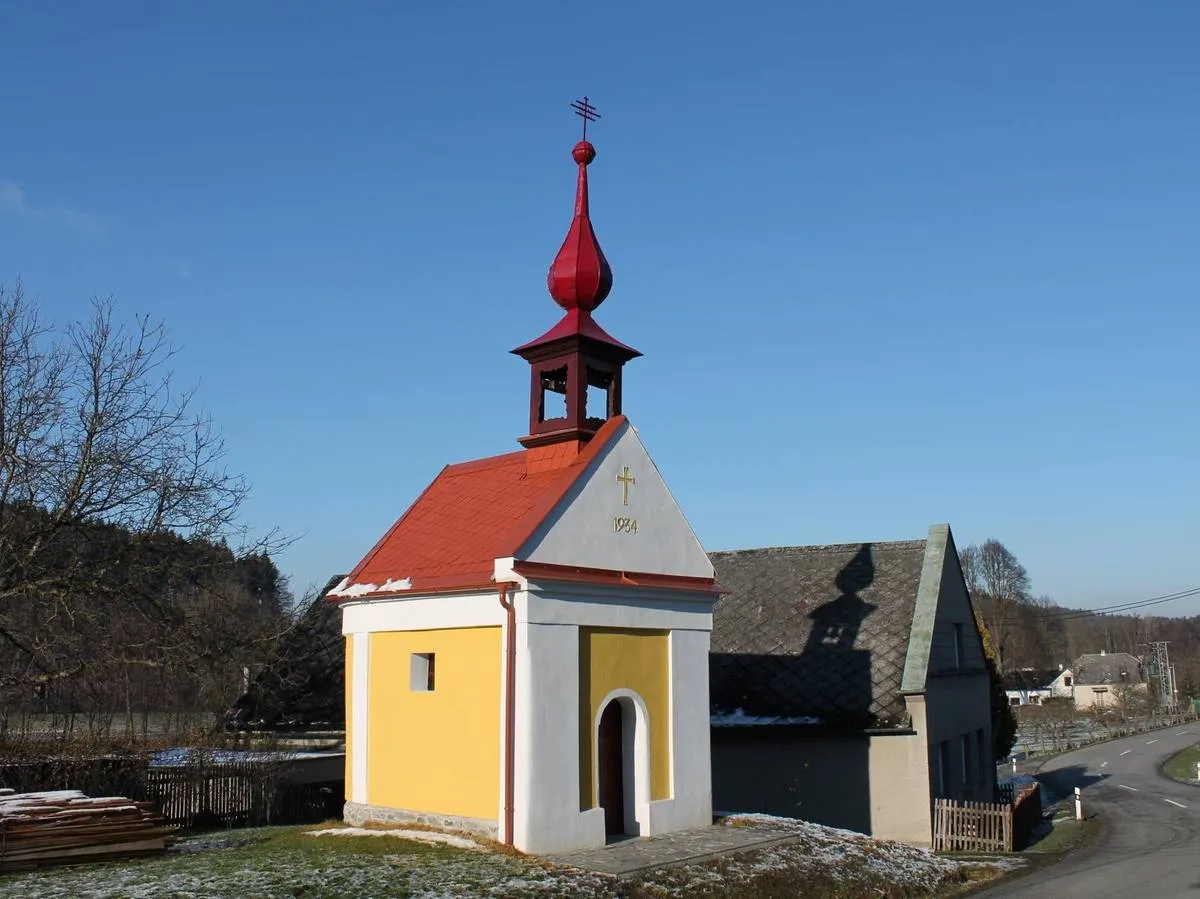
[709,525,996,845]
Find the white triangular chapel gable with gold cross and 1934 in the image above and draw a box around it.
[514,421,713,579]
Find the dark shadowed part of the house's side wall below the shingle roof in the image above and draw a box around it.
[712,726,871,833]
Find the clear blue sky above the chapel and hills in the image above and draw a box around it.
[0,0,1200,613]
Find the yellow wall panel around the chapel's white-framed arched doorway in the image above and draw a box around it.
[580,628,671,809]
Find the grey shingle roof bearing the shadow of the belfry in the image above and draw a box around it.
[709,540,925,727]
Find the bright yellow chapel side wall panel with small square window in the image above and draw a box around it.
[367,628,503,821]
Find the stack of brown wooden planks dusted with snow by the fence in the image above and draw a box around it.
[0,790,175,871]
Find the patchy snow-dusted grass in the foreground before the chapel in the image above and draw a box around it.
[0,821,1012,899]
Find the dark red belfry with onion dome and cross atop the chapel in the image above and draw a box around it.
[512,97,641,446]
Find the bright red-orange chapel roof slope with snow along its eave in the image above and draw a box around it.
[330,415,625,599]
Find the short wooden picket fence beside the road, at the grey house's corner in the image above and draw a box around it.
[934,784,1042,852]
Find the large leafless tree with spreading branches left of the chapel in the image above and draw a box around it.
[0,282,282,705]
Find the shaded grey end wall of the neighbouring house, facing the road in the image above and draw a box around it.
[925,553,996,802]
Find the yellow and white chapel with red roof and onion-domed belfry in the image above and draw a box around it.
[326,108,718,853]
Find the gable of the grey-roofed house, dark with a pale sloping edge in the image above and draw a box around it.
[904,525,986,693]
